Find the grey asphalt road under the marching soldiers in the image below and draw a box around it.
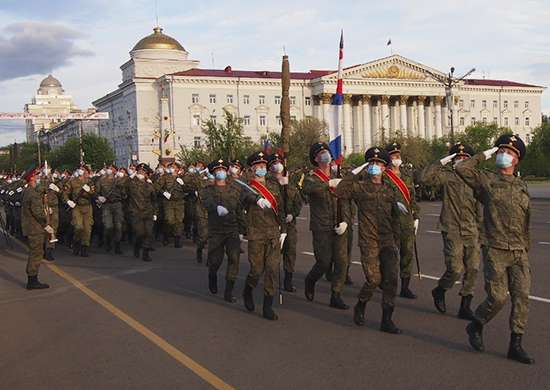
[0,193,550,390]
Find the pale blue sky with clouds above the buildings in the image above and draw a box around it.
[0,0,550,146]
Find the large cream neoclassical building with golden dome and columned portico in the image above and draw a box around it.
[93,27,546,166]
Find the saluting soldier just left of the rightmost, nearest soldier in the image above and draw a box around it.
[420,142,483,321]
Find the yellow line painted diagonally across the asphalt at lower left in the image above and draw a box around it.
[7,236,236,390]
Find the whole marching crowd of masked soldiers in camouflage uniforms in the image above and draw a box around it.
[0,135,534,364]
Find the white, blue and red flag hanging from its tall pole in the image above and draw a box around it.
[325,31,344,165]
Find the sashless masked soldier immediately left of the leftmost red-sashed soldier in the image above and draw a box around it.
[201,158,246,302]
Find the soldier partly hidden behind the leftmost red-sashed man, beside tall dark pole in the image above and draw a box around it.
[267,153,302,292]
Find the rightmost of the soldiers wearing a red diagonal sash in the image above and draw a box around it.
[383,142,420,299]
